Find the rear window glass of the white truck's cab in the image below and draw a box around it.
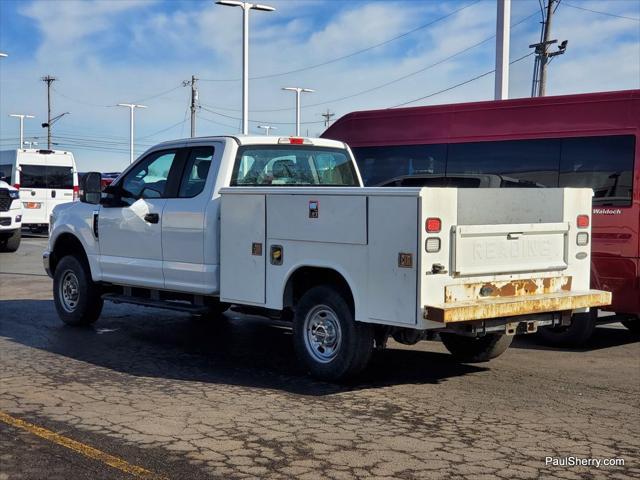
[231,145,359,187]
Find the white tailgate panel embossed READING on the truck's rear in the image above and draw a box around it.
[452,222,569,276]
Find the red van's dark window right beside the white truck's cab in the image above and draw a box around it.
[353,145,447,185]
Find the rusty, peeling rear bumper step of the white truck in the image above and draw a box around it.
[423,290,611,324]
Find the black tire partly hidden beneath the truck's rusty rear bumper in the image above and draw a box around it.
[440,333,513,363]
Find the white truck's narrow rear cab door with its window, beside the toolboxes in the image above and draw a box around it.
[162,144,223,293]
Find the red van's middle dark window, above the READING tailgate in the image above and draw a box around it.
[447,140,560,187]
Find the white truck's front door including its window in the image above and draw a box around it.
[98,149,180,288]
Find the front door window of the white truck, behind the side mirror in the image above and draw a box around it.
[121,151,176,201]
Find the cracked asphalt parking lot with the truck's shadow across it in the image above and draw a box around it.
[0,238,640,480]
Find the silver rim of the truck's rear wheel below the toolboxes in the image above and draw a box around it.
[304,305,342,363]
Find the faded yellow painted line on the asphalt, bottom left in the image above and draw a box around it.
[0,412,167,480]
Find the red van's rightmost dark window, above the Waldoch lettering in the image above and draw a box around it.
[560,135,635,205]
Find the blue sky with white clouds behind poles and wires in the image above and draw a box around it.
[0,0,640,171]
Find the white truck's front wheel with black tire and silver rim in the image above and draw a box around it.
[53,255,103,326]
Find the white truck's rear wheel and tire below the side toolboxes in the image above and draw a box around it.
[293,285,374,381]
